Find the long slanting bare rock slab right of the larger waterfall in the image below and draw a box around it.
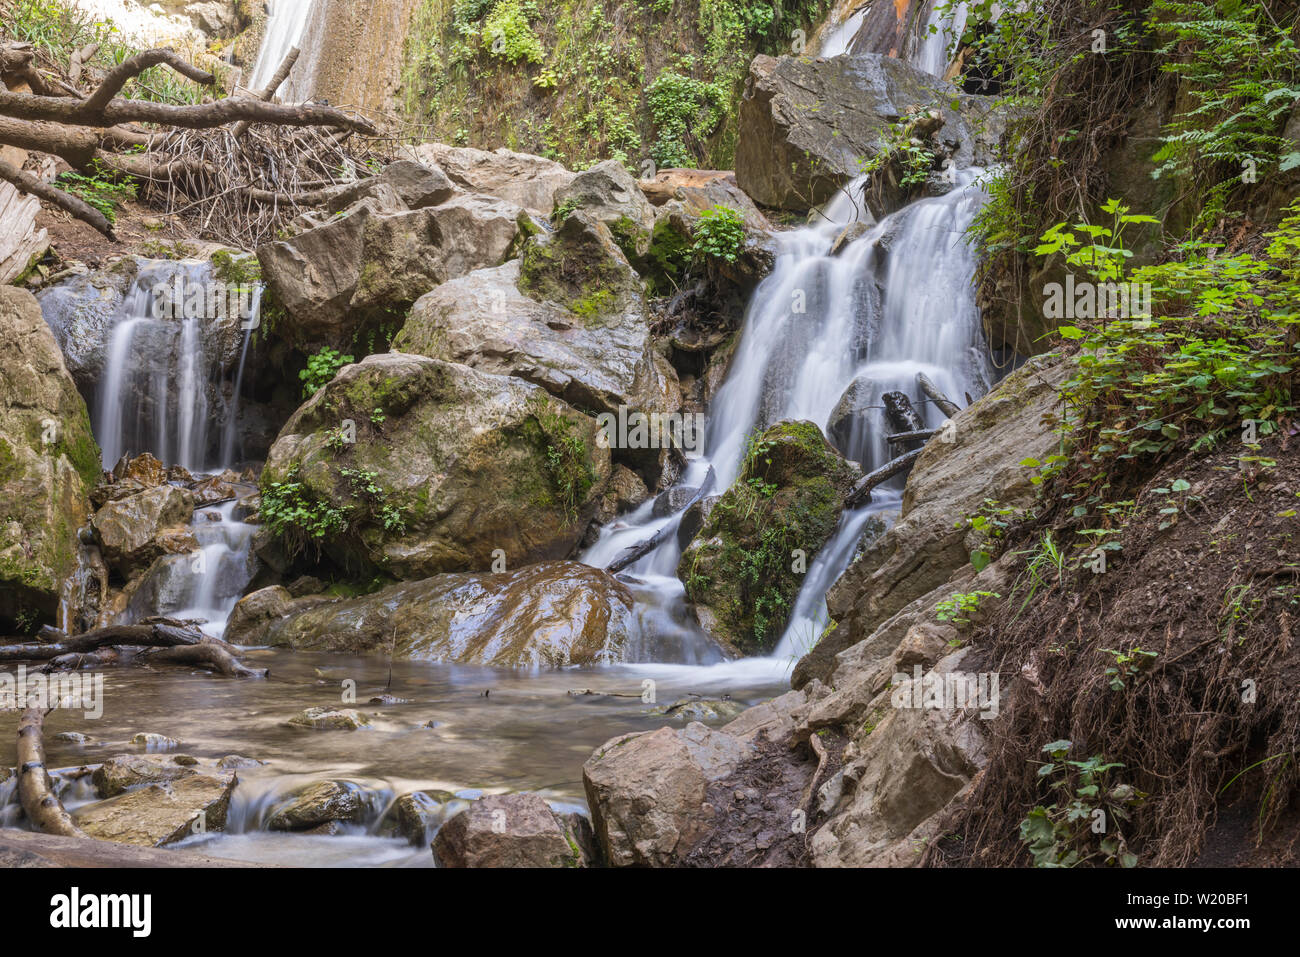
[792,358,1069,687]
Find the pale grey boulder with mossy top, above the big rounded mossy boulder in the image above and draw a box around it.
[393,215,680,413]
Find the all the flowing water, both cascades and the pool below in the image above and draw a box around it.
[0,65,992,866]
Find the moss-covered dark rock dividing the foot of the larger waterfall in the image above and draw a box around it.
[677,421,857,654]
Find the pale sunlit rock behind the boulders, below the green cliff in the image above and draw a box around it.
[400,143,573,218]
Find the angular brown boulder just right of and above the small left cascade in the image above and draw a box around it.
[257,182,521,351]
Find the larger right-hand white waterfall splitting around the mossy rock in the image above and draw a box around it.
[582,169,995,658]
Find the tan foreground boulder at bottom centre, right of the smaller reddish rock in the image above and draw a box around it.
[582,722,751,867]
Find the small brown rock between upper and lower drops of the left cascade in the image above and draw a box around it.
[91,485,199,577]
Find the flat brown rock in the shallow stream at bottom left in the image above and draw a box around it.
[73,768,235,846]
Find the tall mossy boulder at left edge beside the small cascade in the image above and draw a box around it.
[0,286,99,633]
